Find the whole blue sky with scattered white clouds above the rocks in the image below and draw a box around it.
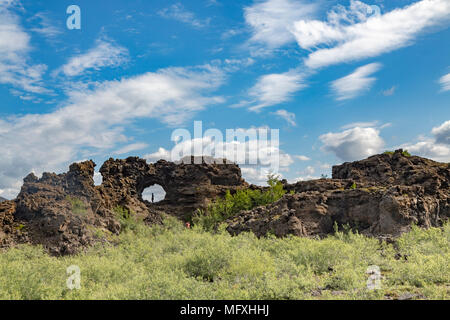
[0,0,450,198]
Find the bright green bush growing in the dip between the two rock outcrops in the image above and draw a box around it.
[192,175,286,230]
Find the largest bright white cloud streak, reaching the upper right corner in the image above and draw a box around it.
[292,0,450,68]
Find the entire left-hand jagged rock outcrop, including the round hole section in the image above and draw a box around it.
[0,157,247,255]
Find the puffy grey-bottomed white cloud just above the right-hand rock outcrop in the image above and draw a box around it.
[319,127,384,161]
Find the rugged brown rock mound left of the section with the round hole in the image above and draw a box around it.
[15,161,120,255]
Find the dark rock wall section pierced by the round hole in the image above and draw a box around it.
[99,158,248,218]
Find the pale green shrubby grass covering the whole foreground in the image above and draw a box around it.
[0,216,450,299]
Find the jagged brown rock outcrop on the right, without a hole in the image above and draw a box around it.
[228,150,450,236]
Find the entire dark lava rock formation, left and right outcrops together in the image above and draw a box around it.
[0,150,450,255]
